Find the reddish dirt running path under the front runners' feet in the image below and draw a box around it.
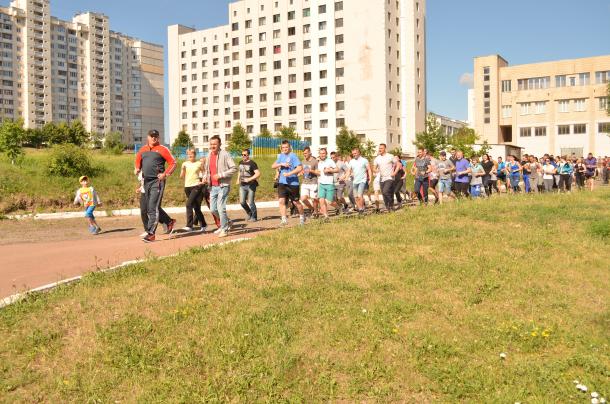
[0,209,280,299]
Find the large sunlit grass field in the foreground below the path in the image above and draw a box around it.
[0,189,610,403]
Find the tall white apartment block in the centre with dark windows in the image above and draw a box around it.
[168,0,426,152]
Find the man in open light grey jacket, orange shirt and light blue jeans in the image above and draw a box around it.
[206,135,237,237]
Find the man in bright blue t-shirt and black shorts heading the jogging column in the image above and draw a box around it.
[271,140,305,226]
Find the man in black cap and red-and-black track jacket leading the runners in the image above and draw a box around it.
[135,129,176,243]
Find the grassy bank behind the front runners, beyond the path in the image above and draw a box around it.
[0,149,275,214]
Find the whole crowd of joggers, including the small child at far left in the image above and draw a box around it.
[75,130,610,243]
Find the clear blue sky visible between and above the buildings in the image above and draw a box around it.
[0,0,610,129]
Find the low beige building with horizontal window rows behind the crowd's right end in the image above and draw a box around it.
[473,55,610,156]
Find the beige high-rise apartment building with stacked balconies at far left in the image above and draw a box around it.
[0,0,164,143]
